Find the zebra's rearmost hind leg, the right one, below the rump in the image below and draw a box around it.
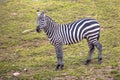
[94,41,102,64]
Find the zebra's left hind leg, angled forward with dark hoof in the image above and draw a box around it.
[85,42,95,65]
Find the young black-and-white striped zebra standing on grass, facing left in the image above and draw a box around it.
[36,10,102,70]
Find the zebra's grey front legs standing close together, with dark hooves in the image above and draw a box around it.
[55,45,64,70]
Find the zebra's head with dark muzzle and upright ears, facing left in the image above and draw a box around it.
[36,10,47,32]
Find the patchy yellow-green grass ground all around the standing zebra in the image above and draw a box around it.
[0,0,120,80]
